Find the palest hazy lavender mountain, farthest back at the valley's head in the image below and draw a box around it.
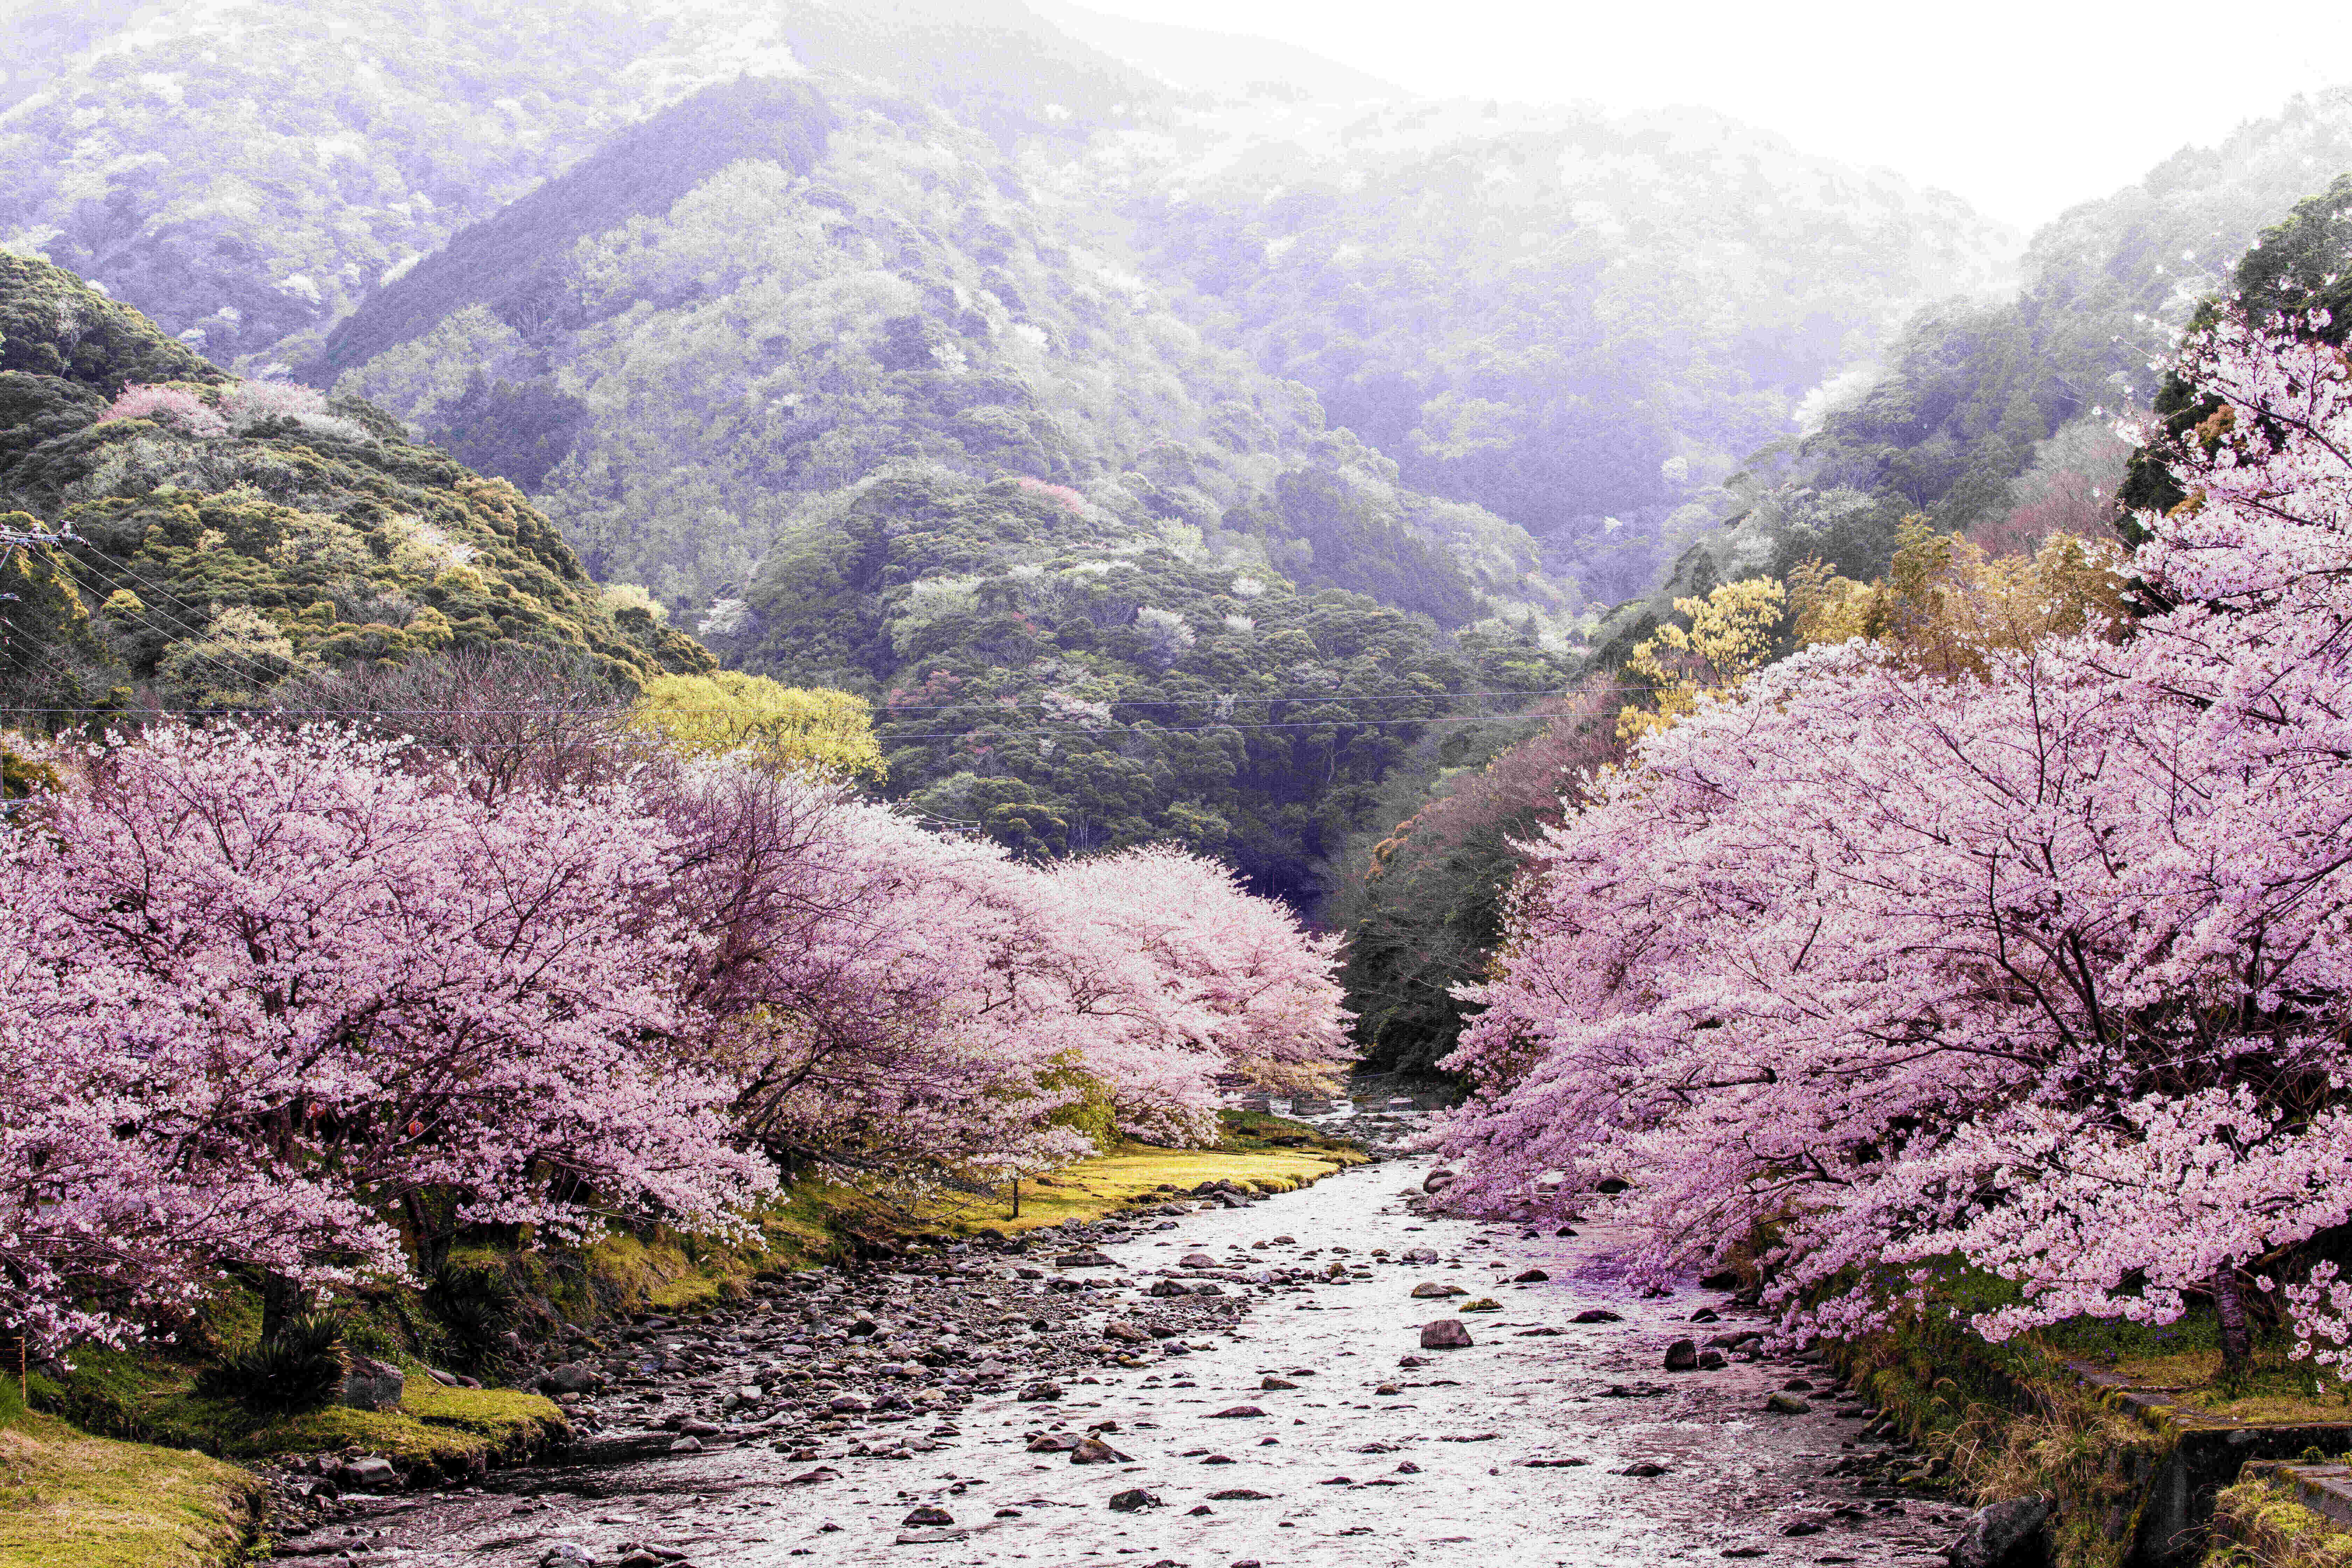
[1086,99,2011,602]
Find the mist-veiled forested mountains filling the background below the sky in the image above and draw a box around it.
[0,0,2352,893]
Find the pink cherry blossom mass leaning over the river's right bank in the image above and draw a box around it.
[1447,303,2352,1354]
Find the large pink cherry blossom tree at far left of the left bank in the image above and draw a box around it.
[0,726,771,1354]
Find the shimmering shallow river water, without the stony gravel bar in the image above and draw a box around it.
[282,1142,1964,1568]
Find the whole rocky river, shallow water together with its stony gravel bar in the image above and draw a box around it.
[267,1133,1964,1568]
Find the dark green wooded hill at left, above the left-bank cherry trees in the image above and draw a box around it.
[0,256,713,724]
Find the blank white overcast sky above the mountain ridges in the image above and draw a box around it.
[1077,0,2352,226]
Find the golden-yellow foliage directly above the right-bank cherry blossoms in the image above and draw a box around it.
[1787,517,2124,675]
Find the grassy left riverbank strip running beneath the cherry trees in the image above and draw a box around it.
[18,1112,1366,1568]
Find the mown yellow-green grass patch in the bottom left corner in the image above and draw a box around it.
[0,1380,261,1568]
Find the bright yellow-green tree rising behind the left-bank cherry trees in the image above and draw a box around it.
[630,670,884,783]
